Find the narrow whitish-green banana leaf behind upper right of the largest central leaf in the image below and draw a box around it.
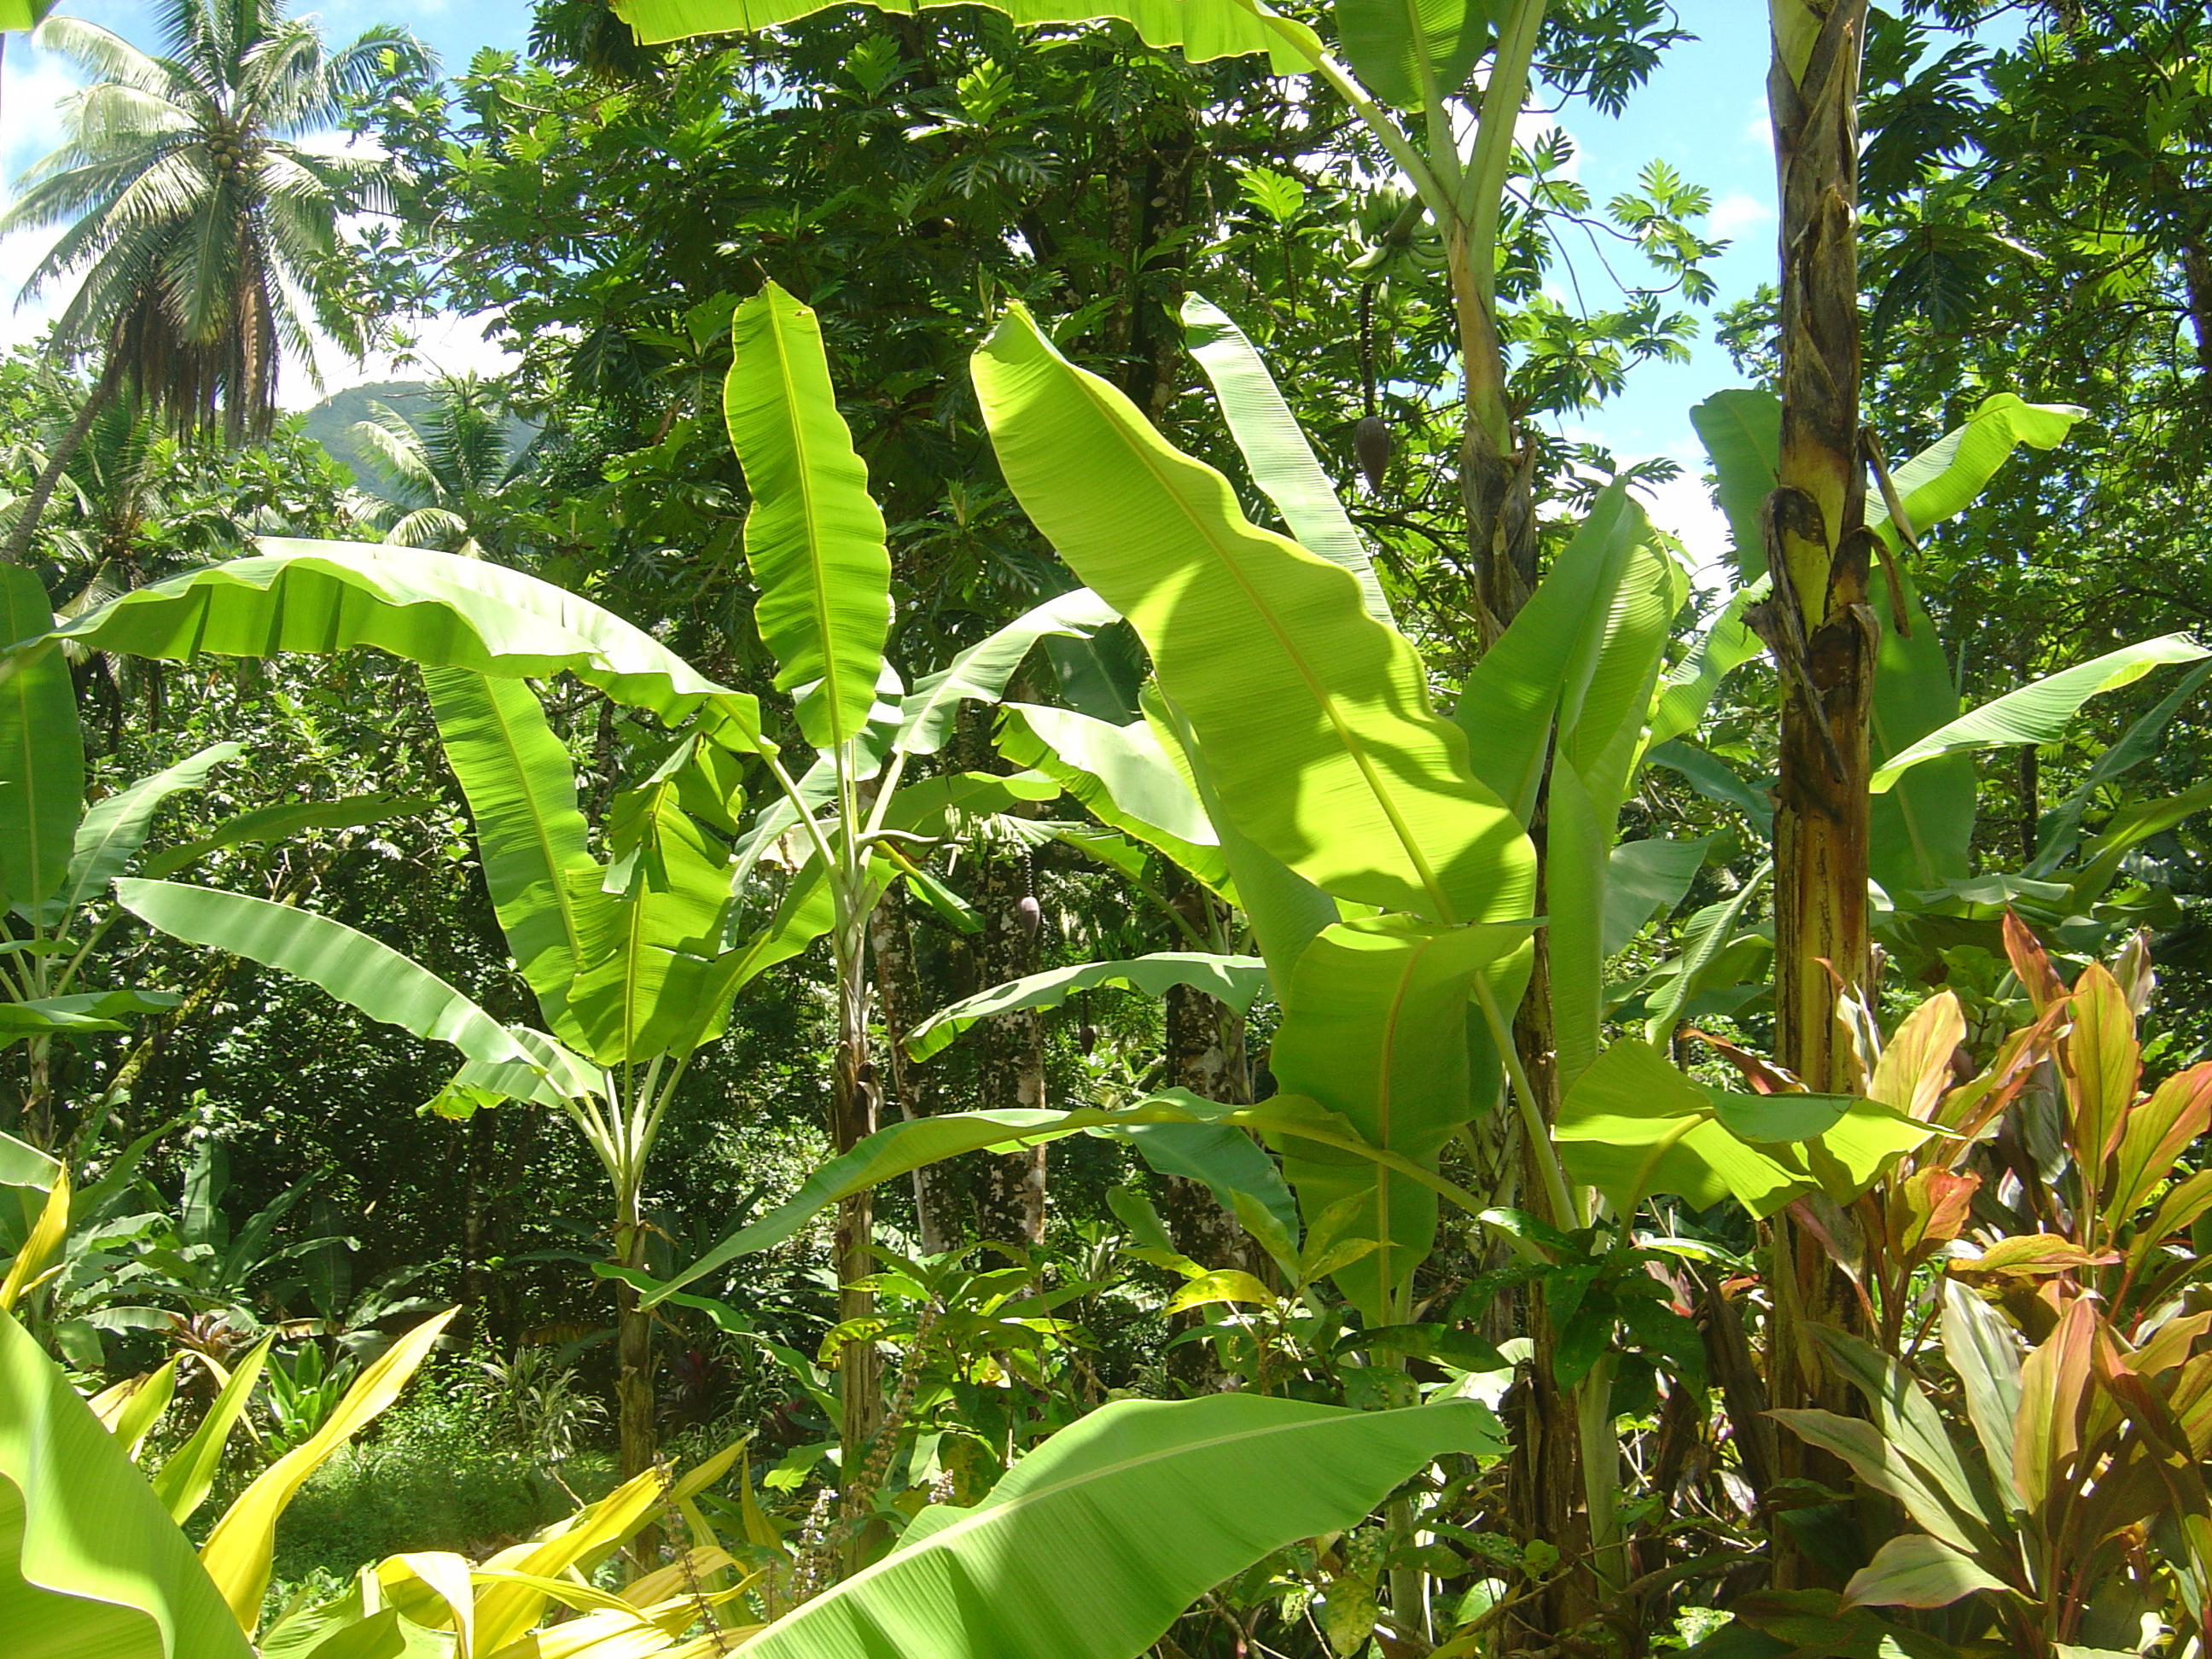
[1184,296,1380,628]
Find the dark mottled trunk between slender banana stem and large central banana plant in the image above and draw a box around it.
[975,841,1044,1245]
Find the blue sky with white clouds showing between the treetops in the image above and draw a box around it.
[0,0,1774,553]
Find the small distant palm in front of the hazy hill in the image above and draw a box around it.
[352,374,528,560]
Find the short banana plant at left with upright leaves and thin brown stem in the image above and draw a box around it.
[117,668,823,1476]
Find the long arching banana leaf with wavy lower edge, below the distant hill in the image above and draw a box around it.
[33,538,734,730]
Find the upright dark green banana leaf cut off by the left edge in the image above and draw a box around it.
[0,564,84,916]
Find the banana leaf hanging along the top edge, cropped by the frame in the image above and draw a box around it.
[615,0,1320,75]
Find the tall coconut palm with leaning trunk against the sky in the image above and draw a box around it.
[0,0,429,562]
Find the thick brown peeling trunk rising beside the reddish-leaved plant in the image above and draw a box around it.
[1761,0,1876,1588]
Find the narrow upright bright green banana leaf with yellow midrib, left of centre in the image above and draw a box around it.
[724,283,892,750]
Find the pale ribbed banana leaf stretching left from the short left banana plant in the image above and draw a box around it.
[115,881,562,1099]
